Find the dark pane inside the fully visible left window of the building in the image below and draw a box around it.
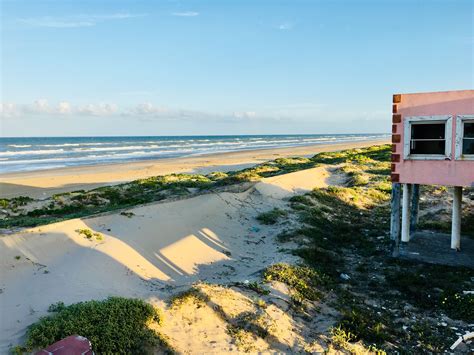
[410,123,446,154]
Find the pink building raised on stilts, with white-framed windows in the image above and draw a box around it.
[392,90,474,253]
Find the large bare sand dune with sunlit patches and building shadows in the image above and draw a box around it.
[0,167,340,352]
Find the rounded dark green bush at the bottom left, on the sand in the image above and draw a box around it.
[17,297,170,354]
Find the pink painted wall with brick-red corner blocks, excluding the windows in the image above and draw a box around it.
[392,90,474,187]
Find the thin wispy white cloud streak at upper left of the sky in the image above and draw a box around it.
[16,13,147,28]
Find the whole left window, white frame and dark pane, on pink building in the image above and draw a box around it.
[404,116,452,160]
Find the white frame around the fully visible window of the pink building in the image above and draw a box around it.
[403,115,453,160]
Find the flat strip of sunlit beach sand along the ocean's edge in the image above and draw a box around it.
[0,138,389,198]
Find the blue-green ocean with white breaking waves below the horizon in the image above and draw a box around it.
[0,134,389,173]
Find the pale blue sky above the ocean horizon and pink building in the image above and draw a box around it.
[0,0,474,136]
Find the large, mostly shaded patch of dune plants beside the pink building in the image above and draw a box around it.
[264,146,474,353]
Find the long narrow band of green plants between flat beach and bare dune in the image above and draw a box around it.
[0,154,317,228]
